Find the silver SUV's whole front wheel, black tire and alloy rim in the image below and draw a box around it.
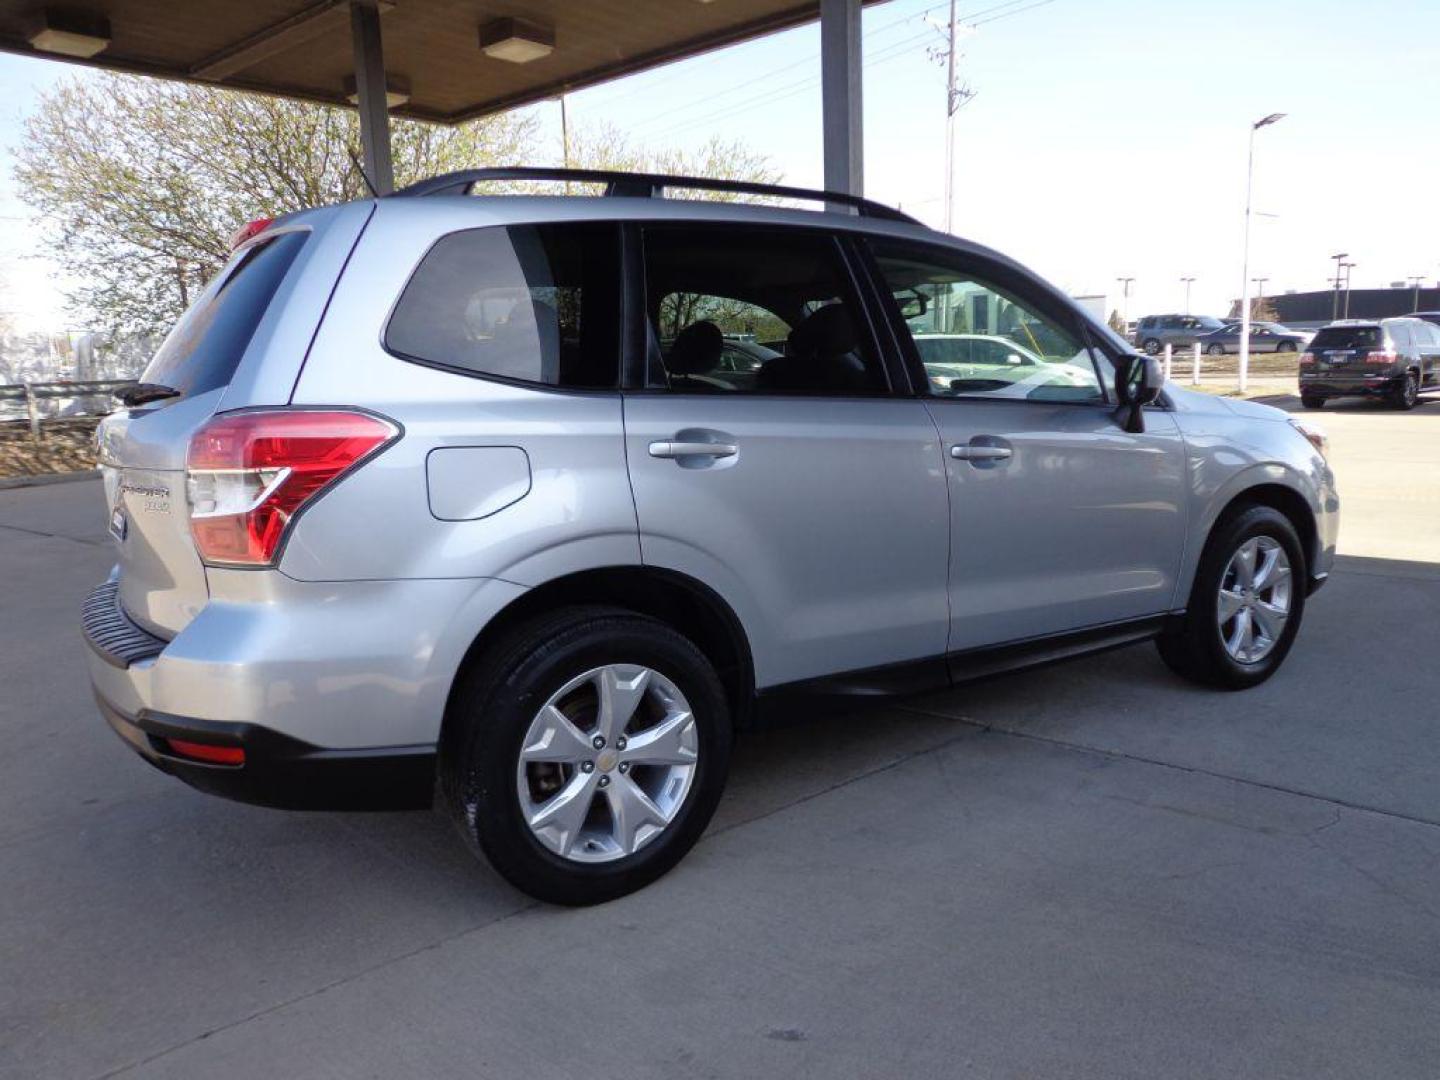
[1156,505,1306,690]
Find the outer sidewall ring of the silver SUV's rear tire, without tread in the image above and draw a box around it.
[458,615,732,904]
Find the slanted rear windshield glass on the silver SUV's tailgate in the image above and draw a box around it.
[140,232,310,396]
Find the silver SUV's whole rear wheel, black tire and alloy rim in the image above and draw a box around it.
[441,608,730,904]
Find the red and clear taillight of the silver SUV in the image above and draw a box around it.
[186,409,400,566]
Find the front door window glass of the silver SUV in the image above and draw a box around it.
[871,240,1104,402]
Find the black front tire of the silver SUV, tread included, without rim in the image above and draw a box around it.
[1155,504,1309,690]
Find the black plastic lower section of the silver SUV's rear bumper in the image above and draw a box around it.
[95,694,435,811]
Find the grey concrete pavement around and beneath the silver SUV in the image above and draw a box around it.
[0,402,1440,1080]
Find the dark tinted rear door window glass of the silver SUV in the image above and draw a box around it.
[644,226,888,395]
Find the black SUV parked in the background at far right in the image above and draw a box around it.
[1300,318,1440,409]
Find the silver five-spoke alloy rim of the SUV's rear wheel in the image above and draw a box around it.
[516,664,700,863]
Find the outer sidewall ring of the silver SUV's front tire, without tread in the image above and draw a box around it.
[1192,507,1309,690]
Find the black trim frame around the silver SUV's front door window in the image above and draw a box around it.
[860,235,1119,409]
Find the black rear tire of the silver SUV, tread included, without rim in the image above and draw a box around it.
[439,606,732,906]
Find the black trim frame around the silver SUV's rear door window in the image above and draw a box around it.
[622,219,912,402]
